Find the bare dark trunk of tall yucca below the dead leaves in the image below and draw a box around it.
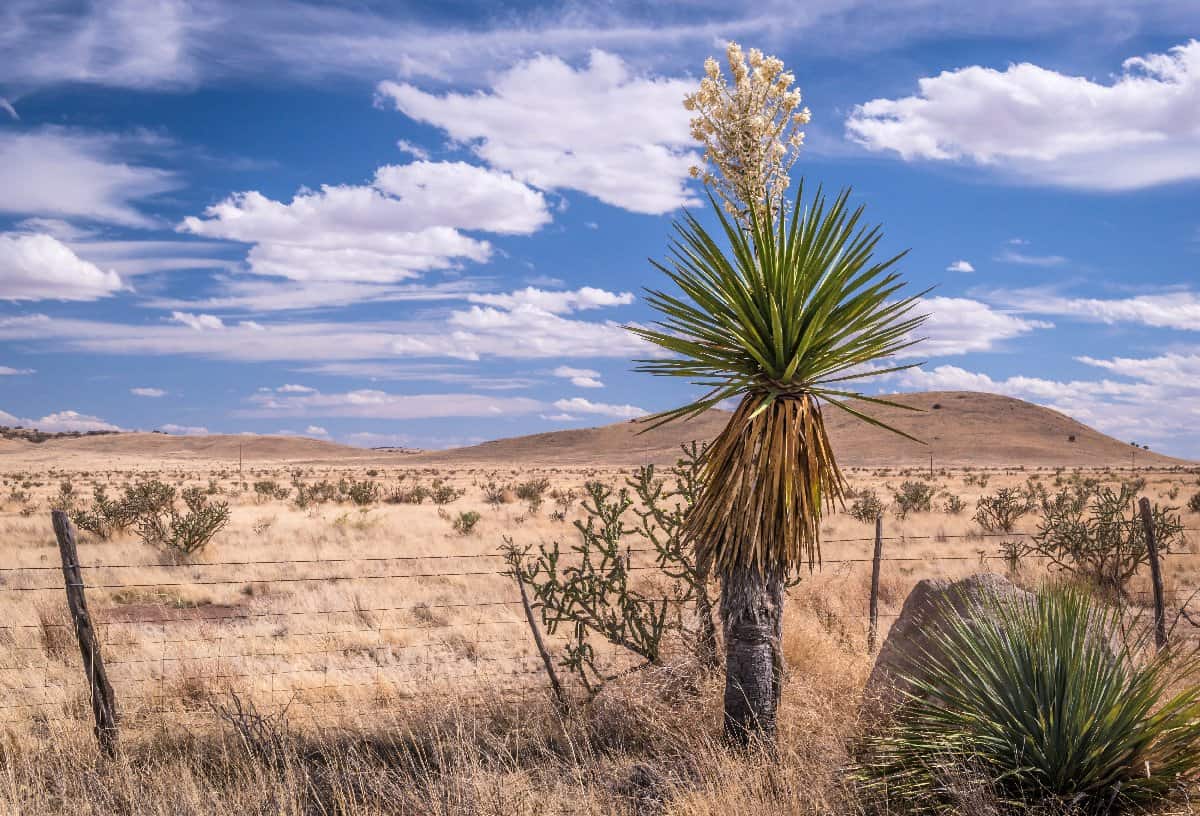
[721,566,784,746]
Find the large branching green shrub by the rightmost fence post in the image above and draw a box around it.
[1030,485,1183,598]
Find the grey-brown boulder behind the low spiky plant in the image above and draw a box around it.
[864,572,1033,722]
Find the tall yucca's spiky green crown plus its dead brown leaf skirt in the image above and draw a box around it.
[630,182,925,571]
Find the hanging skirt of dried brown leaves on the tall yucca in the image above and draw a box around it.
[686,392,846,572]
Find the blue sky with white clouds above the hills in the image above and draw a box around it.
[0,0,1200,457]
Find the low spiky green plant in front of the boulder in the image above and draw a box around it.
[864,588,1200,814]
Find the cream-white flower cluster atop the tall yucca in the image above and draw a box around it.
[683,42,811,223]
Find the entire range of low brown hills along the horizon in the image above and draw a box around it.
[0,391,1194,468]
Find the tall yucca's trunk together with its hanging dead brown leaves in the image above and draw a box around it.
[688,394,844,745]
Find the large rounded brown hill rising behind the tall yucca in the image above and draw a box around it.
[407,391,1190,468]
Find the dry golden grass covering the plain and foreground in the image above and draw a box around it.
[0,460,1200,816]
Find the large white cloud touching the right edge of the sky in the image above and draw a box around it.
[846,40,1200,190]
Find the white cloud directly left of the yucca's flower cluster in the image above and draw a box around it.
[379,50,697,214]
